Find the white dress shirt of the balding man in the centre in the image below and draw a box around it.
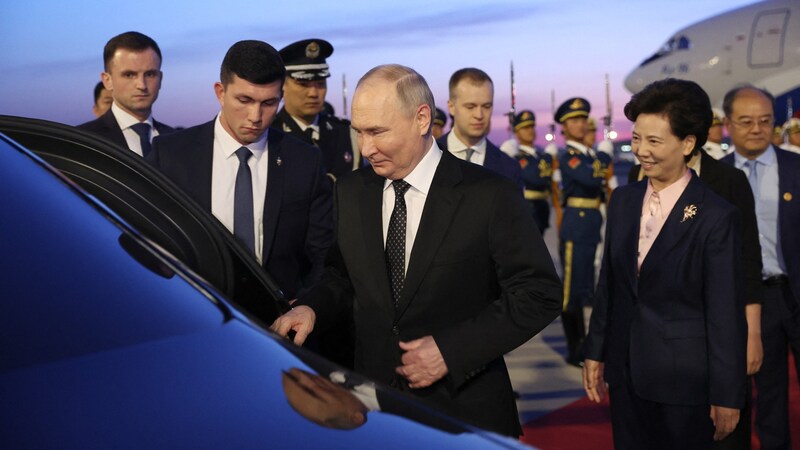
[382,140,442,272]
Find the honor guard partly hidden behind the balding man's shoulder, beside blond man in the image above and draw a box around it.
[514,110,553,234]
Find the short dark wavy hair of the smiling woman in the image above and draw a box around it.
[624,78,714,157]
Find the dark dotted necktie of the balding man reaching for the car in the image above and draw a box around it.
[386,180,411,308]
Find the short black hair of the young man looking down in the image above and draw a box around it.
[219,40,286,85]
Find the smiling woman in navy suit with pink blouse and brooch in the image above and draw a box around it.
[583,79,747,450]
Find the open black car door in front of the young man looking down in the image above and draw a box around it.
[0,115,288,325]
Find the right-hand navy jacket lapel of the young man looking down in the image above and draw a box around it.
[261,132,285,261]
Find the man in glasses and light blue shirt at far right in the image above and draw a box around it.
[722,85,800,449]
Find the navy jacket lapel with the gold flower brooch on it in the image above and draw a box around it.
[639,172,703,273]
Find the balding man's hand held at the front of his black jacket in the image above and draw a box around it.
[395,336,447,389]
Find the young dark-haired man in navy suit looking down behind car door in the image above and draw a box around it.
[148,41,332,298]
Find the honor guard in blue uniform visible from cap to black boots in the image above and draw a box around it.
[555,97,607,366]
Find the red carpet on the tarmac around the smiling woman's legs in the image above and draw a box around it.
[521,354,800,450]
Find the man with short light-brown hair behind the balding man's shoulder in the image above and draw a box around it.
[436,68,525,188]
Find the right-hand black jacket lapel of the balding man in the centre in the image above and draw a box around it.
[396,151,462,320]
